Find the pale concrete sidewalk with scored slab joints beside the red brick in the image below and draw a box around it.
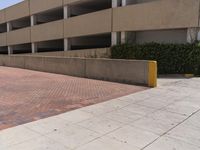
[0,78,200,150]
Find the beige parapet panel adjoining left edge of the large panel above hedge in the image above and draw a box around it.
[64,9,112,38]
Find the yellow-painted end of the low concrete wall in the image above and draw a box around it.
[148,61,158,87]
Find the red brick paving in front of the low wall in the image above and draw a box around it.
[0,67,146,130]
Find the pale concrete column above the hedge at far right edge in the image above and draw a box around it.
[187,28,200,43]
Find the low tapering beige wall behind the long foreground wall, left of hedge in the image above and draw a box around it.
[24,48,111,58]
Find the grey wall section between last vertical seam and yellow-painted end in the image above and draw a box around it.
[86,59,148,84]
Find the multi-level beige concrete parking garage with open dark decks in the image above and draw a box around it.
[0,0,200,54]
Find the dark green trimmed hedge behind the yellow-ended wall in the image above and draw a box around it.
[111,43,200,75]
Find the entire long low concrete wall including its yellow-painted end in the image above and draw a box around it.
[0,55,157,87]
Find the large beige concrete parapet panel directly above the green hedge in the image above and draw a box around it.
[113,0,199,32]
